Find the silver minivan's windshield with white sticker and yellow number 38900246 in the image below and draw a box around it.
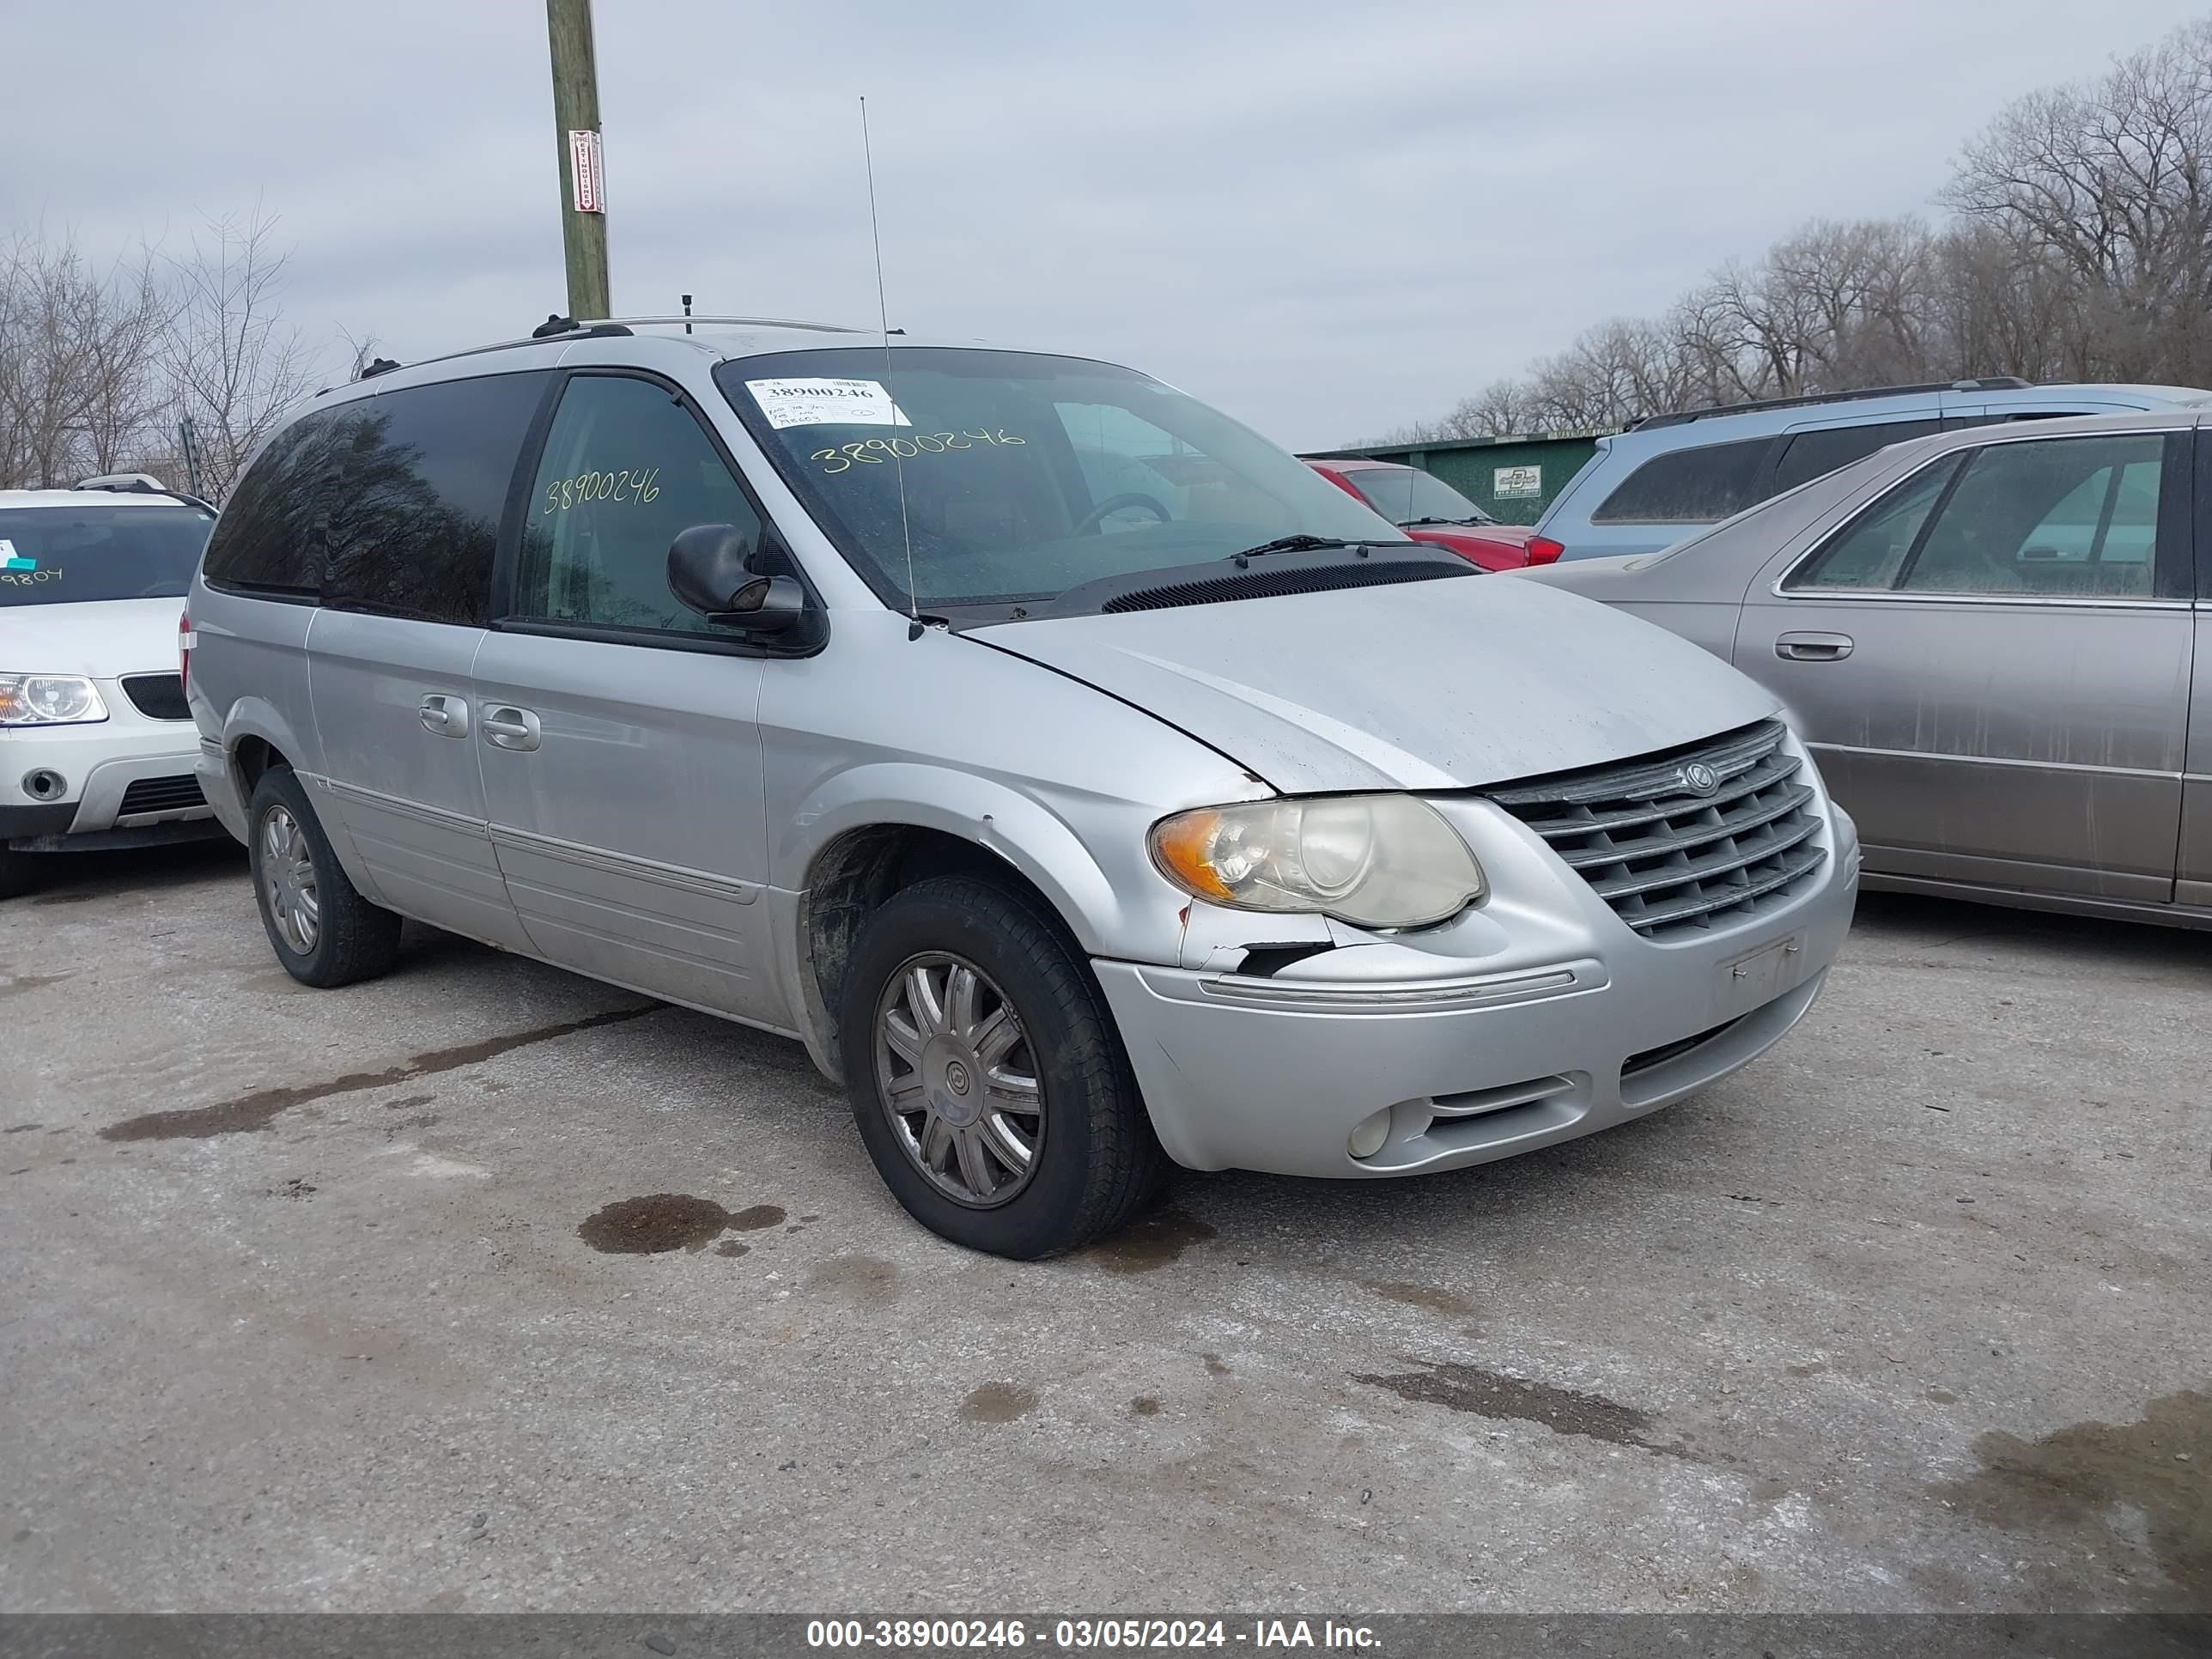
[714,347,1405,608]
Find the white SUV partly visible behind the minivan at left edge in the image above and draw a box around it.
[0,484,223,898]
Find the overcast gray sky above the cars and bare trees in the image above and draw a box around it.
[0,0,2208,447]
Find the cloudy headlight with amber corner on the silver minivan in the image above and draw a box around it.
[1152,794,1482,927]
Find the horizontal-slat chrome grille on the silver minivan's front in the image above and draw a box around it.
[1484,721,1827,940]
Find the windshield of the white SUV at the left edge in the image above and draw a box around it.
[0,507,215,606]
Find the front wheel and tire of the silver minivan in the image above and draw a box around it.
[838,876,1166,1261]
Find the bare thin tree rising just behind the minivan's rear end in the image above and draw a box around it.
[161,208,314,500]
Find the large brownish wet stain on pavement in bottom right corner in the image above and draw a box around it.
[1929,1389,2212,1613]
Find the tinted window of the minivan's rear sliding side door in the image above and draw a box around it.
[323,372,549,623]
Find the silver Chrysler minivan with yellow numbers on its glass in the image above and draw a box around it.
[185,319,1858,1256]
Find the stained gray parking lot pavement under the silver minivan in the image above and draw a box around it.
[0,848,2212,1613]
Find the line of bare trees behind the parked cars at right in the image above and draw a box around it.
[1380,18,2212,435]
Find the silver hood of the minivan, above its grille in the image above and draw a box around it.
[971,577,1777,794]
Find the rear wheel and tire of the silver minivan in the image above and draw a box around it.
[246,765,400,991]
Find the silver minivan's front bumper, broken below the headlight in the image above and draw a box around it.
[1095,801,1858,1179]
